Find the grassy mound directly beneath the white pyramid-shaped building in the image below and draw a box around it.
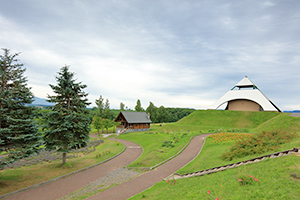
[159,110,282,133]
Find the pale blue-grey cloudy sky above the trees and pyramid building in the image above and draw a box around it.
[0,0,300,110]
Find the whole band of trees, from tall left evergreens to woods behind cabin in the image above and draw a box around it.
[0,49,194,169]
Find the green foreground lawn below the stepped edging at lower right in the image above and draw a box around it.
[130,155,300,200]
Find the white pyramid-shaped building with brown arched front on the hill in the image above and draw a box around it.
[208,76,282,112]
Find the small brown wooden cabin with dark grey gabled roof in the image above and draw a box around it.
[115,111,152,134]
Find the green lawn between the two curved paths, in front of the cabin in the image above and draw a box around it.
[118,129,190,167]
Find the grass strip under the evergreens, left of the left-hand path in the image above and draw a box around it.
[0,139,124,195]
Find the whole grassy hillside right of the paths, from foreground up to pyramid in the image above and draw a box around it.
[130,110,300,199]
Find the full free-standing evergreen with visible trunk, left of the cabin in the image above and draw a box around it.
[44,66,90,165]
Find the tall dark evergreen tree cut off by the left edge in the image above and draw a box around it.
[0,49,41,169]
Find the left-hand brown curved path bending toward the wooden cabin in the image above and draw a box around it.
[6,139,142,200]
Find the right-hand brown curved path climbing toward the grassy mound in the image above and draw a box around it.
[87,134,209,200]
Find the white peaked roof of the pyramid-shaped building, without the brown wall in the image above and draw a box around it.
[208,76,282,112]
